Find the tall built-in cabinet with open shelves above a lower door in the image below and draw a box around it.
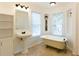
[0,14,14,56]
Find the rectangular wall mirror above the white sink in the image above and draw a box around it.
[15,9,28,30]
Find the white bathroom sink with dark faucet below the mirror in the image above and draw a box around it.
[16,30,31,39]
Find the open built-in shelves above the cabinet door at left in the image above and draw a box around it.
[0,14,13,38]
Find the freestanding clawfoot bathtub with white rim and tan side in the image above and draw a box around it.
[41,35,67,49]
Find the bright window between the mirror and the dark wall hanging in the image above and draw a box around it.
[32,12,41,36]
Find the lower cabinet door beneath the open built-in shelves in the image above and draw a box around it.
[1,38,13,56]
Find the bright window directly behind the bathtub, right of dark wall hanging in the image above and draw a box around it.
[52,13,64,36]
